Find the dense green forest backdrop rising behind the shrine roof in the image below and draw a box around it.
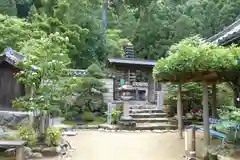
[0,0,240,65]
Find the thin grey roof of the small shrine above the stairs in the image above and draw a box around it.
[108,58,156,66]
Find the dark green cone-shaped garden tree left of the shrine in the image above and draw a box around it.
[65,64,106,119]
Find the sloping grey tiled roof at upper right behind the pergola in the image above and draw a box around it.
[207,19,240,45]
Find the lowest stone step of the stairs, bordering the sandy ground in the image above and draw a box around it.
[135,123,177,130]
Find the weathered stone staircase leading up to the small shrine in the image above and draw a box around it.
[130,105,177,130]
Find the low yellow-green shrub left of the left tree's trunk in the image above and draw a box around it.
[17,125,37,144]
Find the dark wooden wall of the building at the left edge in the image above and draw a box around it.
[0,62,25,110]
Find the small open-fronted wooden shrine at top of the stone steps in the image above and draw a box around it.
[107,46,159,103]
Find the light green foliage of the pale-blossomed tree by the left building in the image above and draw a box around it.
[13,33,72,111]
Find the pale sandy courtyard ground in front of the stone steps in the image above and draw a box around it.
[43,131,184,160]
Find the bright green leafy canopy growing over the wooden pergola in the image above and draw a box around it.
[153,37,240,80]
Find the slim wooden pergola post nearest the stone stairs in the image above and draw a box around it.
[177,84,183,139]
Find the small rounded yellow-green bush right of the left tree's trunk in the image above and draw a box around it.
[45,127,61,146]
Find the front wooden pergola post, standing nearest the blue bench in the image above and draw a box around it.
[203,82,210,153]
